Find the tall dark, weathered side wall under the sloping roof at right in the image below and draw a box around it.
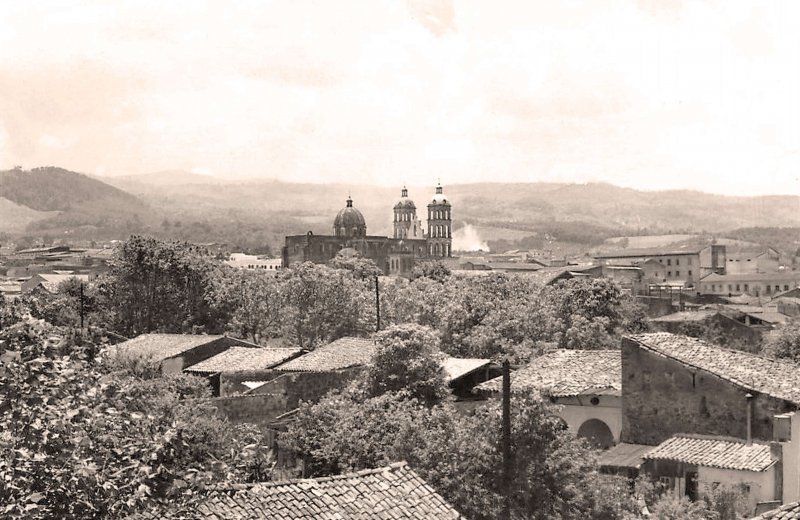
[621,338,794,445]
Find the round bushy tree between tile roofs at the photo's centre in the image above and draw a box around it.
[366,324,447,404]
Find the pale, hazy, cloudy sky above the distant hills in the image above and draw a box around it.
[0,0,800,195]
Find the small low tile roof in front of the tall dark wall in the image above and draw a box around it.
[643,435,777,471]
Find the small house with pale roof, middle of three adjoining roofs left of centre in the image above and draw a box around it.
[184,346,303,396]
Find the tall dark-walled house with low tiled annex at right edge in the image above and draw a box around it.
[621,332,800,509]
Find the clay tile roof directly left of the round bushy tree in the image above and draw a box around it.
[276,338,375,372]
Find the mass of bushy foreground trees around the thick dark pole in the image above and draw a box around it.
[279,388,615,520]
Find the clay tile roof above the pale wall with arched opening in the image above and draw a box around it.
[477,350,622,397]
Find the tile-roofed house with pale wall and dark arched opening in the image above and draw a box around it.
[476,349,622,448]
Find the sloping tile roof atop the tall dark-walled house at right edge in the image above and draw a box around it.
[628,332,800,404]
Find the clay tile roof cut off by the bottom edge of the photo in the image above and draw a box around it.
[133,462,463,520]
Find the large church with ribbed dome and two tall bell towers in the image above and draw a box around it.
[282,184,453,276]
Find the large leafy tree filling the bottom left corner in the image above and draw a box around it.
[0,321,270,519]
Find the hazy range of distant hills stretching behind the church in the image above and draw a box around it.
[0,168,800,255]
